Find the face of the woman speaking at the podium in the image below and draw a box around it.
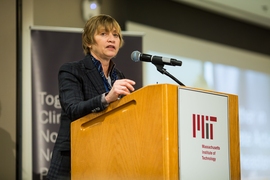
[89,29,120,60]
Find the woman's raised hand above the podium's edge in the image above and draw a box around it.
[105,79,135,103]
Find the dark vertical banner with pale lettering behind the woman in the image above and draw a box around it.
[31,28,142,180]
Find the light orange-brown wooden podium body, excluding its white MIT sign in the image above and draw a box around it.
[71,84,241,180]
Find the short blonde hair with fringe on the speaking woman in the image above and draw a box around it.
[82,14,124,55]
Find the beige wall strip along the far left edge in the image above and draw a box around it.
[0,0,16,179]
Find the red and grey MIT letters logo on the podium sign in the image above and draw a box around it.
[192,114,217,139]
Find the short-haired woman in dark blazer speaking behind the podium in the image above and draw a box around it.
[47,14,135,180]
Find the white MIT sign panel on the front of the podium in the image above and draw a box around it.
[178,88,230,180]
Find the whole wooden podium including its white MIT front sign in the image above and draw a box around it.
[71,84,241,180]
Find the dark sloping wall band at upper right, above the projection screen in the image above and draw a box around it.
[101,0,270,55]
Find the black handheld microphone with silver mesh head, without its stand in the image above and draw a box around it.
[131,51,182,66]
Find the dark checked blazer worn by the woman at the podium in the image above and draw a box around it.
[47,55,124,179]
